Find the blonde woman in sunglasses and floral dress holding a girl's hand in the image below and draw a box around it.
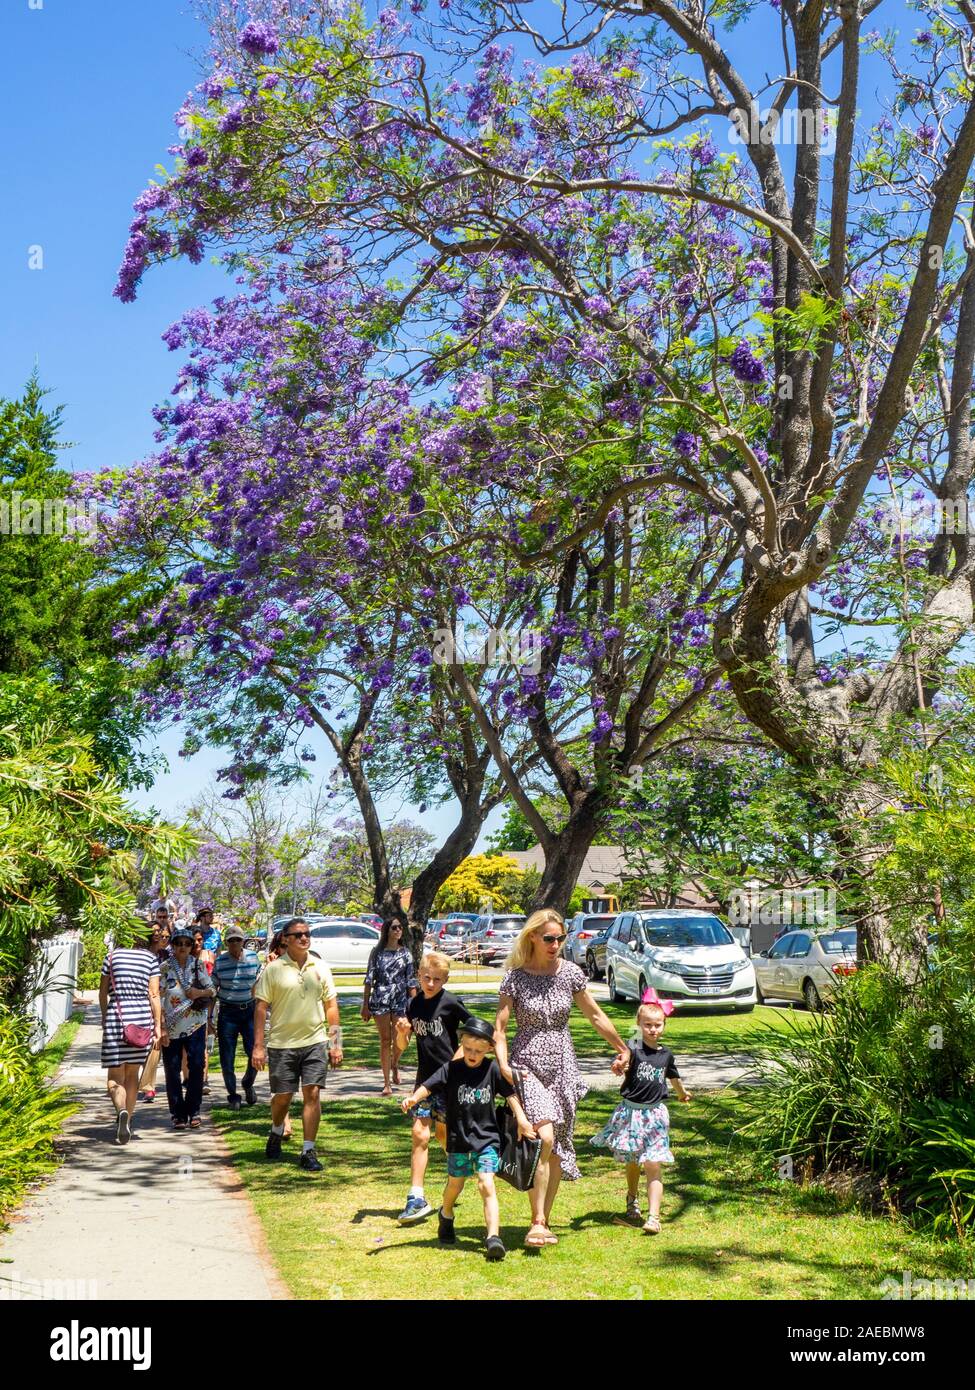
[495,908,630,1248]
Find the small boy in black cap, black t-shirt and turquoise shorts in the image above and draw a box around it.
[402,1019,535,1259]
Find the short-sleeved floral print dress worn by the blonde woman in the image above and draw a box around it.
[499,960,588,1182]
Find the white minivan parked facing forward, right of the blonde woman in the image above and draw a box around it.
[606,908,755,1013]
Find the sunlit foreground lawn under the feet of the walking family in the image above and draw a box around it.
[216,1093,957,1300]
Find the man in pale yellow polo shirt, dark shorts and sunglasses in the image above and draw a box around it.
[250,917,342,1173]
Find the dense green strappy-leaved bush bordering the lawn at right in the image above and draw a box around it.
[739,938,975,1238]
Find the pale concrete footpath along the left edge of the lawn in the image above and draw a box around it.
[0,1004,288,1300]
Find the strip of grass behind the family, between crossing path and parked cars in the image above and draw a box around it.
[331,987,809,1069]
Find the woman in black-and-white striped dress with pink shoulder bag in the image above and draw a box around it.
[99,941,163,1144]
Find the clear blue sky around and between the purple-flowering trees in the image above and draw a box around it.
[0,0,912,833]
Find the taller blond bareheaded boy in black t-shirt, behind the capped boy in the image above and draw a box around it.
[396,951,470,1226]
